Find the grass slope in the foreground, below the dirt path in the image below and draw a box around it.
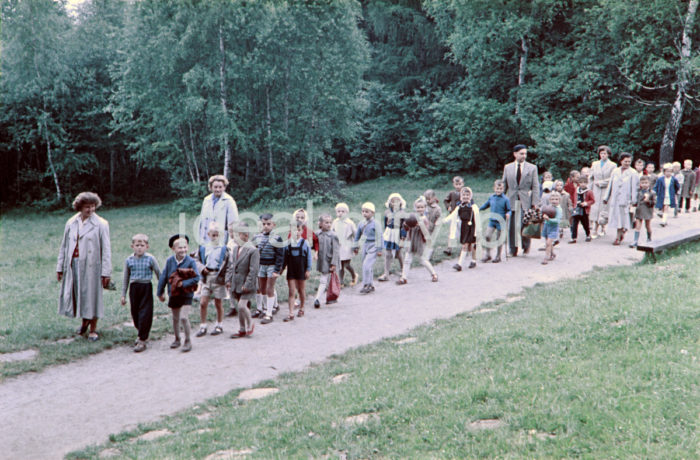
[69,244,700,459]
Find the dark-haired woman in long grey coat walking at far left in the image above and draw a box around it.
[56,192,112,342]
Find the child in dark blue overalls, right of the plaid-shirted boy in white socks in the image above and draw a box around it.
[282,221,313,322]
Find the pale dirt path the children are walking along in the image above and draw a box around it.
[0,213,700,459]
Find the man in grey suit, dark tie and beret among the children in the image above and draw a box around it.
[503,144,540,257]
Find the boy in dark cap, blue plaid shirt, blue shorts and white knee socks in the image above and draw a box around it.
[253,213,284,324]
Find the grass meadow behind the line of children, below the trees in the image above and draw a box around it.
[0,176,490,379]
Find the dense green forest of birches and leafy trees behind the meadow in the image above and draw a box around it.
[0,0,700,209]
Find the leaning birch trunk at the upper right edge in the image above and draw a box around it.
[659,0,699,165]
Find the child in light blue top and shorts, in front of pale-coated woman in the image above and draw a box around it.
[194,222,229,337]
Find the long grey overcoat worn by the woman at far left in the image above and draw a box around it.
[56,213,112,319]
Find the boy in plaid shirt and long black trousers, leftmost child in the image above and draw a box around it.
[121,233,160,353]
